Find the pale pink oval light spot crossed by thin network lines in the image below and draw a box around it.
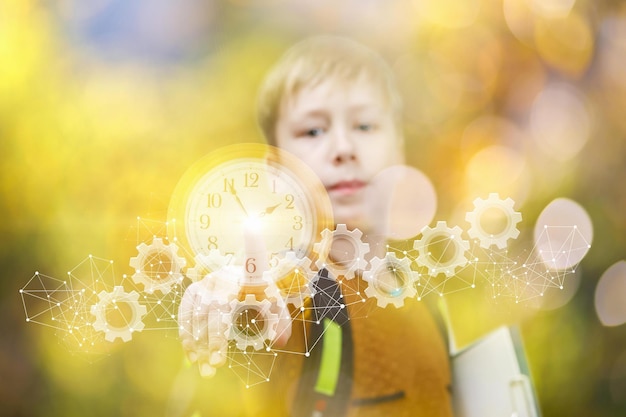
[534,198,593,270]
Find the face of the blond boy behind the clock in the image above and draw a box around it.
[276,77,404,233]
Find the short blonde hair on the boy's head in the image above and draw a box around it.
[257,36,402,145]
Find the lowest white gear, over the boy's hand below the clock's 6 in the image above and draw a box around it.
[223,294,279,350]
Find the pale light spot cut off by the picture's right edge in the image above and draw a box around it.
[595,261,626,326]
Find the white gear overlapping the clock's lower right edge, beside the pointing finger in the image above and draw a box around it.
[263,251,317,308]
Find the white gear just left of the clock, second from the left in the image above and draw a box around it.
[130,237,187,294]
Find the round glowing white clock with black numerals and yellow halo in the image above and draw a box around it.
[168,143,333,264]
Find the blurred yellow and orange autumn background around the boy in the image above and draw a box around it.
[0,0,626,417]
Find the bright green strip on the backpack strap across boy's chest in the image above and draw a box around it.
[315,318,341,397]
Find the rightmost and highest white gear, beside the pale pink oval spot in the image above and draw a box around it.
[465,193,522,249]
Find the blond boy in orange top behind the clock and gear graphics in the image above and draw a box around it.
[178,36,452,417]
